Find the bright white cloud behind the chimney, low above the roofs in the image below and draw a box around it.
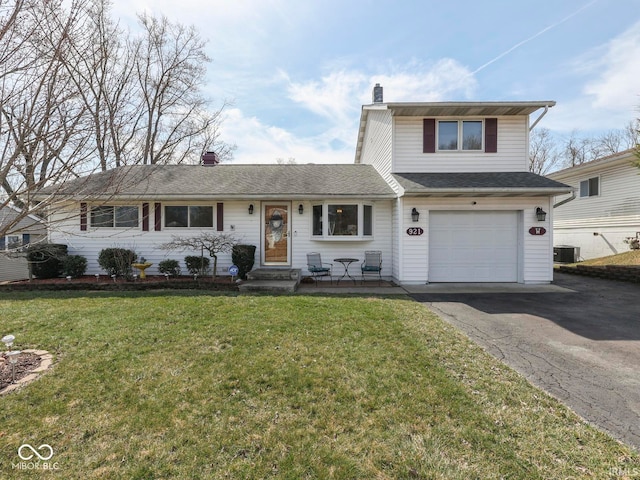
[222,59,476,163]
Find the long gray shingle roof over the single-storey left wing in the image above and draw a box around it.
[40,164,394,198]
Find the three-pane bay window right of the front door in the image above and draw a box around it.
[313,203,373,237]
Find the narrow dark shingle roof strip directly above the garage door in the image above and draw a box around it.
[393,172,571,195]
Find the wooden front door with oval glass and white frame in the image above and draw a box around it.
[262,202,291,266]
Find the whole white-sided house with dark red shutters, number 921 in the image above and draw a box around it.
[36,85,570,284]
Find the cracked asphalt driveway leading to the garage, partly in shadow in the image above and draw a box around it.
[412,273,640,449]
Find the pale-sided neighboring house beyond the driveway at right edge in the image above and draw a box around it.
[547,150,640,260]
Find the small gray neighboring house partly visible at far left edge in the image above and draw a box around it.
[0,205,47,282]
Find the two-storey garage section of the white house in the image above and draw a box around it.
[355,97,570,284]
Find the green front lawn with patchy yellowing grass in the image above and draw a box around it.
[0,292,640,479]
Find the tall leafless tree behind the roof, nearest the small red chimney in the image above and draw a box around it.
[131,14,229,164]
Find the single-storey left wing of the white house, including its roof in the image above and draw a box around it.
[45,165,395,278]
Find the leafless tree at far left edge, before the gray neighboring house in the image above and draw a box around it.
[0,2,95,229]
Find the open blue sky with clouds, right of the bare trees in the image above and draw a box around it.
[113,0,640,163]
